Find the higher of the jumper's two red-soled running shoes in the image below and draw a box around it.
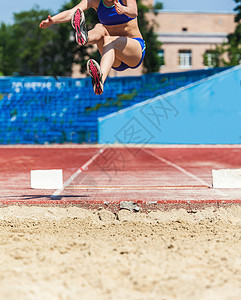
[71,8,88,46]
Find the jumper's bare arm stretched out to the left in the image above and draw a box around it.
[39,0,94,28]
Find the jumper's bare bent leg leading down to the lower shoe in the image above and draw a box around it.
[100,36,142,82]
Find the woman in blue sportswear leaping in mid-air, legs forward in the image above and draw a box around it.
[39,0,146,95]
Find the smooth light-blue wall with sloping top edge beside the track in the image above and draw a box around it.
[98,66,241,144]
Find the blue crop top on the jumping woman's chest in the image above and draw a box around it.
[97,0,135,25]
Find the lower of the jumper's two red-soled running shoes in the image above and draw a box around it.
[87,59,104,95]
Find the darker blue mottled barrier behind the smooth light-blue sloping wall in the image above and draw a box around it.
[0,68,230,144]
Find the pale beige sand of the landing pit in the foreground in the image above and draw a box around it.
[0,206,241,300]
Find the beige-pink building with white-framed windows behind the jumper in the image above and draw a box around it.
[73,7,236,77]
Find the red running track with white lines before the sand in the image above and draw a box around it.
[0,145,241,211]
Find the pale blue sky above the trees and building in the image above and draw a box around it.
[0,0,235,24]
